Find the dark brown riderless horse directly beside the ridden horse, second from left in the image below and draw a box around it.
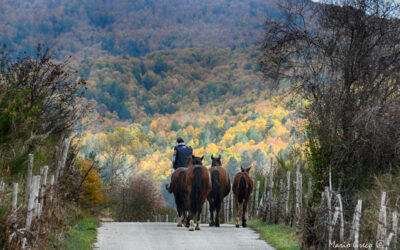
[184,156,211,231]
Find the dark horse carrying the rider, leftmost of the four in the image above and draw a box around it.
[171,168,187,227]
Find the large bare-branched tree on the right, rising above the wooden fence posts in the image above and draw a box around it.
[260,0,400,246]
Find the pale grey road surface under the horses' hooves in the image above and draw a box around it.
[94,222,274,250]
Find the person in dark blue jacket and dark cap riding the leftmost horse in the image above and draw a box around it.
[166,137,193,193]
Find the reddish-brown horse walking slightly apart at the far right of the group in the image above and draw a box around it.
[232,167,253,227]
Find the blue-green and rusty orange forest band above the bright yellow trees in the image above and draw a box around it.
[77,48,268,121]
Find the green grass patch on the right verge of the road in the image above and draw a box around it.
[247,220,300,250]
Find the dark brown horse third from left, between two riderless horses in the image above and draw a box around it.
[207,155,231,227]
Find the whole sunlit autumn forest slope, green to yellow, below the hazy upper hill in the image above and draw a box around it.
[75,44,303,205]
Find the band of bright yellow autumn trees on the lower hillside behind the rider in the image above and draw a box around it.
[83,85,306,187]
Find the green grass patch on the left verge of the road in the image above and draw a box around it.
[65,217,99,250]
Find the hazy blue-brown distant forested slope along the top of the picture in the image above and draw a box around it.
[0,0,276,58]
